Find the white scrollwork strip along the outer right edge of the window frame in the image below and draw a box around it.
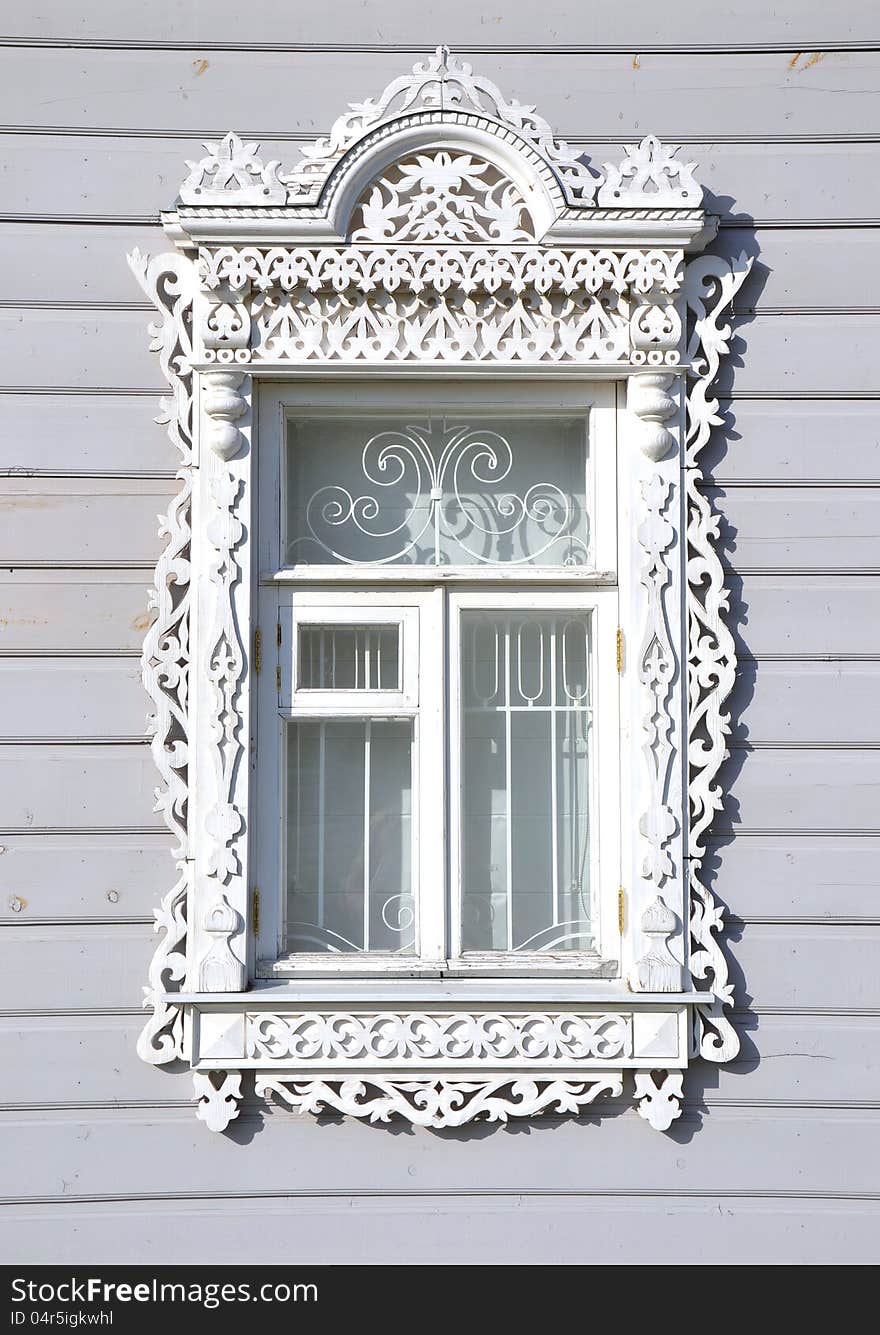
[684,254,753,1061]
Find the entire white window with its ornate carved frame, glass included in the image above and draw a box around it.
[131,48,750,1129]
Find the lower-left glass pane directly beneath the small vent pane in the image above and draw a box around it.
[286,718,415,955]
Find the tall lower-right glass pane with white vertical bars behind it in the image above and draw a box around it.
[461,611,594,952]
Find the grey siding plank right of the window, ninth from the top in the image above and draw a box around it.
[729,661,880,746]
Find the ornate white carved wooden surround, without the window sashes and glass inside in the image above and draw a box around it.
[130,47,752,1131]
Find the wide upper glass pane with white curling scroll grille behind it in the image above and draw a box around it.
[283,413,592,566]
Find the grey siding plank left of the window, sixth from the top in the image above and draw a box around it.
[0,392,179,475]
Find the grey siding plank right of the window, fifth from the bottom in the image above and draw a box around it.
[704,834,880,918]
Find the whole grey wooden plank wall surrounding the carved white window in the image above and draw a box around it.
[0,0,880,1263]
